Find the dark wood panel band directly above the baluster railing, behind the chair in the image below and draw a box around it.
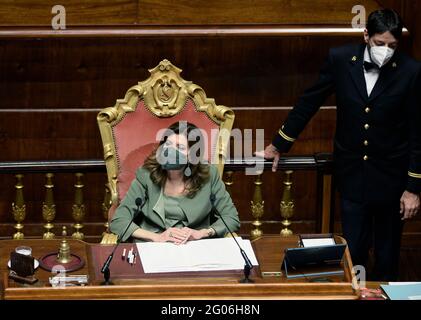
[0,107,336,161]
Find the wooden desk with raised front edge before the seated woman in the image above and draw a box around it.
[0,236,358,299]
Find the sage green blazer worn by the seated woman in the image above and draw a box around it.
[110,165,240,241]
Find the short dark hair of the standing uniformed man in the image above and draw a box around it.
[367,9,403,40]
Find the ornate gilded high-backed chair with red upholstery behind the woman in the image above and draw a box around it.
[97,60,234,243]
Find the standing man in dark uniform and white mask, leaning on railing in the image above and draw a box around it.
[260,9,421,281]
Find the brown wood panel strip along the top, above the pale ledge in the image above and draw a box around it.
[0,0,378,26]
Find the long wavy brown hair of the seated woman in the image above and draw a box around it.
[143,121,210,198]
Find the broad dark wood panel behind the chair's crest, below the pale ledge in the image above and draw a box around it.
[0,36,352,109]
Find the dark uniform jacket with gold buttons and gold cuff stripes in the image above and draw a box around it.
[272,45,421,203]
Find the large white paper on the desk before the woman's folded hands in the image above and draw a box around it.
[136,237,258,273]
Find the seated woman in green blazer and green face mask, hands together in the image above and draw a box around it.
[110,122,240,244]
